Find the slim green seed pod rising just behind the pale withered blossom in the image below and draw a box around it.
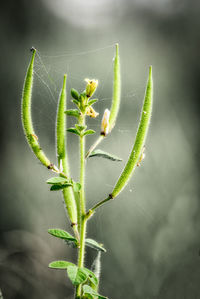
[109,44,121,132]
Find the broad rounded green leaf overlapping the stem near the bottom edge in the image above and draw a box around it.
[67,265,88,285]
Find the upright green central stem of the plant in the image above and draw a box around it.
[75,115,87,298]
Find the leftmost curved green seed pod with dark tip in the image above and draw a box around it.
[22,48,52,170]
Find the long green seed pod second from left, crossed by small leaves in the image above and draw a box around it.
[56,75,78,236]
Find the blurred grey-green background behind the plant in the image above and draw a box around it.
[0,0,200,299]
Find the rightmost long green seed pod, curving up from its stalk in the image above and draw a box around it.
[110,66,153,198]
